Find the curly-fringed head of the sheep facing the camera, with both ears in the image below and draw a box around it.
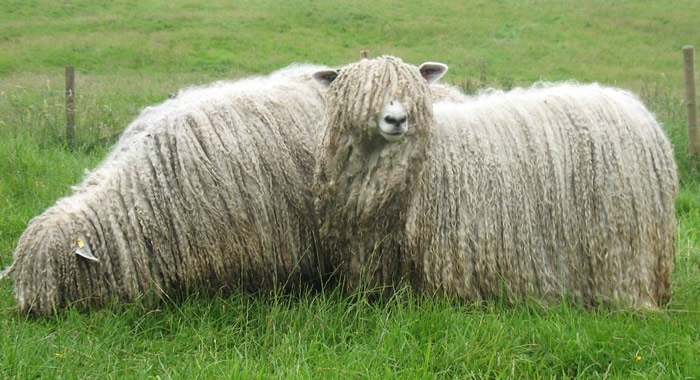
[314,56,447,141]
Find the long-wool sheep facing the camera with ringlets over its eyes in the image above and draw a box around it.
[313,56,678,309]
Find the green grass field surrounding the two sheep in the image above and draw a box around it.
[0,0,700,379]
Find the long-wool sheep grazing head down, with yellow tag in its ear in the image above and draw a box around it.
[2,65,325,314]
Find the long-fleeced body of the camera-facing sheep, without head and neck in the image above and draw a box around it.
[408,84,677,306]
